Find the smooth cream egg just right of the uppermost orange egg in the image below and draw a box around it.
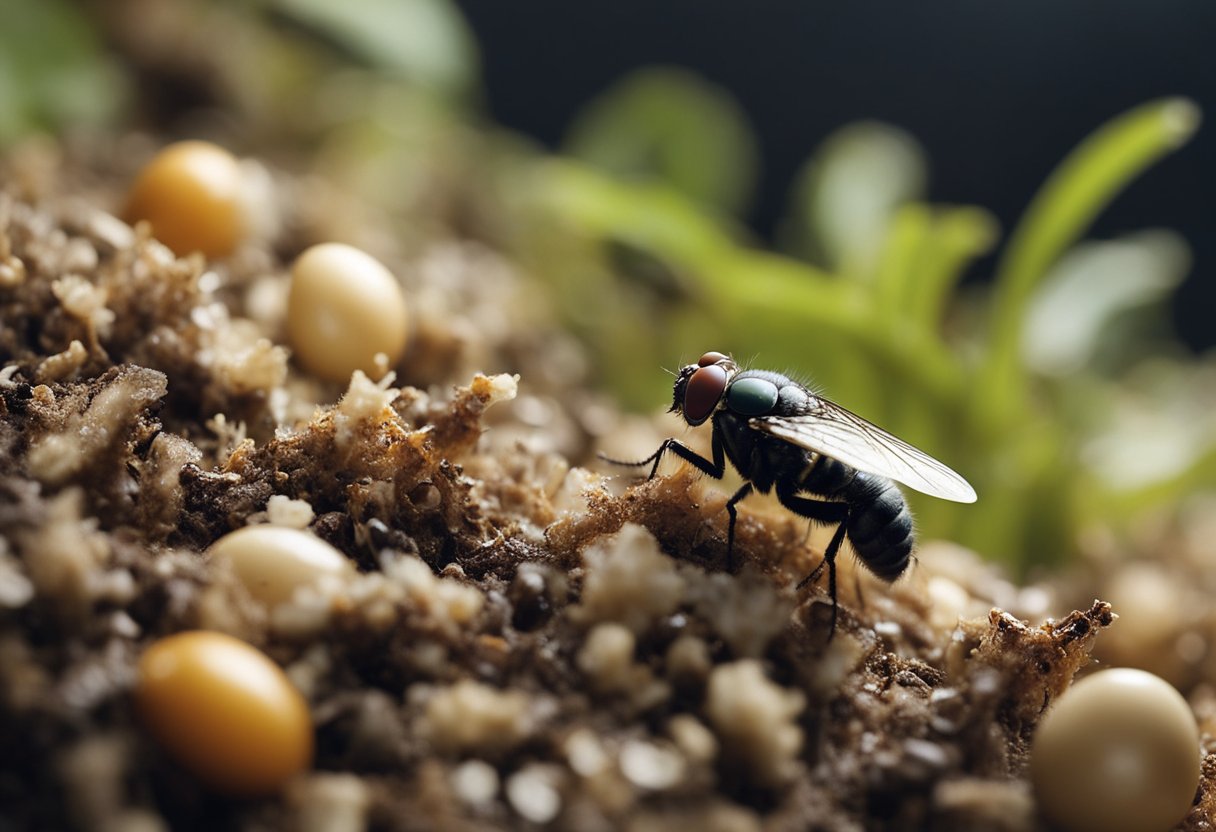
[287,243,409,382]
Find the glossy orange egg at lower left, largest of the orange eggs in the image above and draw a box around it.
[135,630,313,794]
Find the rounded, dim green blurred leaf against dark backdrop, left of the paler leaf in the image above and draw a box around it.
[564,67,758,215]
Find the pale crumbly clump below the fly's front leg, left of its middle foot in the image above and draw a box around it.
[574,523,686,633]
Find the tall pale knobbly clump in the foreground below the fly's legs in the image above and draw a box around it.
[705,659,806,786]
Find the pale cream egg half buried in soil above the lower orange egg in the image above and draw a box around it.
[208,525,351,607]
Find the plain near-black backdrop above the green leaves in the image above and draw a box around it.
[458,0,1216,349]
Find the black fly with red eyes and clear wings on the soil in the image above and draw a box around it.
[604,353,975,633]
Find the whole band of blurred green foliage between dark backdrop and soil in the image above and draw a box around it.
[0,0,1201,566]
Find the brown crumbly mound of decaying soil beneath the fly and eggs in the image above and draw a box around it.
[0,159,1214,832]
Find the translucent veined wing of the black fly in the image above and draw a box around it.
[749,397,975,502]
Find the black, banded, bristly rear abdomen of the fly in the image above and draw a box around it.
[848,473,913,580]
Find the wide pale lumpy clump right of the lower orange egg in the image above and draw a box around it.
[420,679,533,754]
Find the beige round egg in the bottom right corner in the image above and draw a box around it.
[1030,668,1200,832]
